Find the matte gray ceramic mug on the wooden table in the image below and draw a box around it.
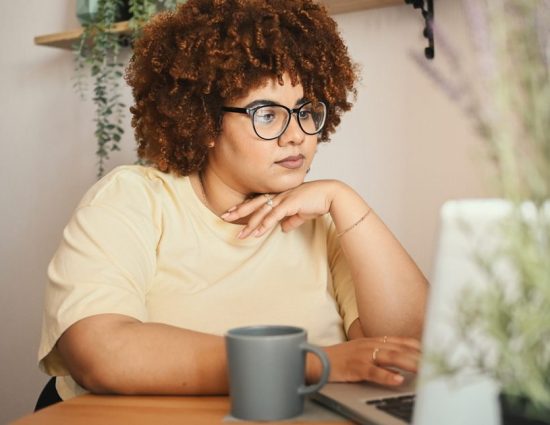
[225,326,330,421]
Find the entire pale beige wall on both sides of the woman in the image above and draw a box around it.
[0,0,492,423]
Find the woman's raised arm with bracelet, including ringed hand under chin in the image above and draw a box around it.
[222,180,427,338]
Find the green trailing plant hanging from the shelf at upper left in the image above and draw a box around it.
[74,0,188,177]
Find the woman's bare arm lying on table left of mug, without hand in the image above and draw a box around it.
[57,314,228,395]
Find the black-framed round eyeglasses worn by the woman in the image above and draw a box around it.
[222,102,327,140]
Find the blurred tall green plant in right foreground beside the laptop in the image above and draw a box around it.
[416,0,550,424]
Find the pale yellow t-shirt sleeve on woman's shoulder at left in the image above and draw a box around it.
[38,169,159,375]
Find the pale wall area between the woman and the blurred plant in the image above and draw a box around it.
[310,0,487,276]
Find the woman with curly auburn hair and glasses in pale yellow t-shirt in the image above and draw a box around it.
[39,0,426,399]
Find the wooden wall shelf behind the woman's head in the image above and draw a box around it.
[34,0,405,50]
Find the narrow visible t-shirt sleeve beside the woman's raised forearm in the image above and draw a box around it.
[327,220,359,335]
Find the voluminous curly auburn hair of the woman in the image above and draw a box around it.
[126,0,357,175]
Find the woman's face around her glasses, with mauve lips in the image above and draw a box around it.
[207,74,318,196]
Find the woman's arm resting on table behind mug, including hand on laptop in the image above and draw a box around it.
[57,314,419,395]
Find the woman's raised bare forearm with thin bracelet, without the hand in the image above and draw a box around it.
[330,182,428,338]
